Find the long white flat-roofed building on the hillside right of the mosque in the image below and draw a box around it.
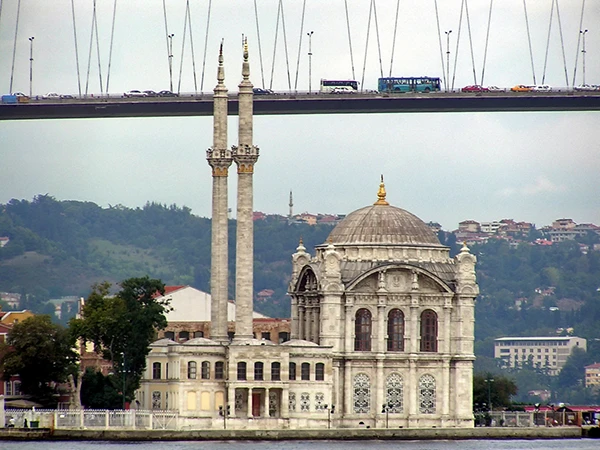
[494,336,587,375]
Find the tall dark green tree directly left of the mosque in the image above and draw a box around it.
[70,277,170,410]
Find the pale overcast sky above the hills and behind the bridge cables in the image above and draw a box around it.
[0,0,600,229]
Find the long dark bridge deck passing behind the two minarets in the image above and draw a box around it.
[0,92,600,120]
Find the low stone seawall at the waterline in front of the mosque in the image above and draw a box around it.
[0,427,587,441]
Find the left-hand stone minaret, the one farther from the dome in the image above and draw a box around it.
[206,42,232,342]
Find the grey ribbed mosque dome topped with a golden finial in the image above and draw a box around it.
[327,177,441,246]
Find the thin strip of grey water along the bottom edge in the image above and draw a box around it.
[0,439,600,450]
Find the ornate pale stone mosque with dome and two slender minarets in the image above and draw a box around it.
[137,43,479,429]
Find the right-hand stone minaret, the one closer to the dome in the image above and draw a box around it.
[232,39,259,339]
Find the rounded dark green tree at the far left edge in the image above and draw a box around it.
[1,316,78,406]
